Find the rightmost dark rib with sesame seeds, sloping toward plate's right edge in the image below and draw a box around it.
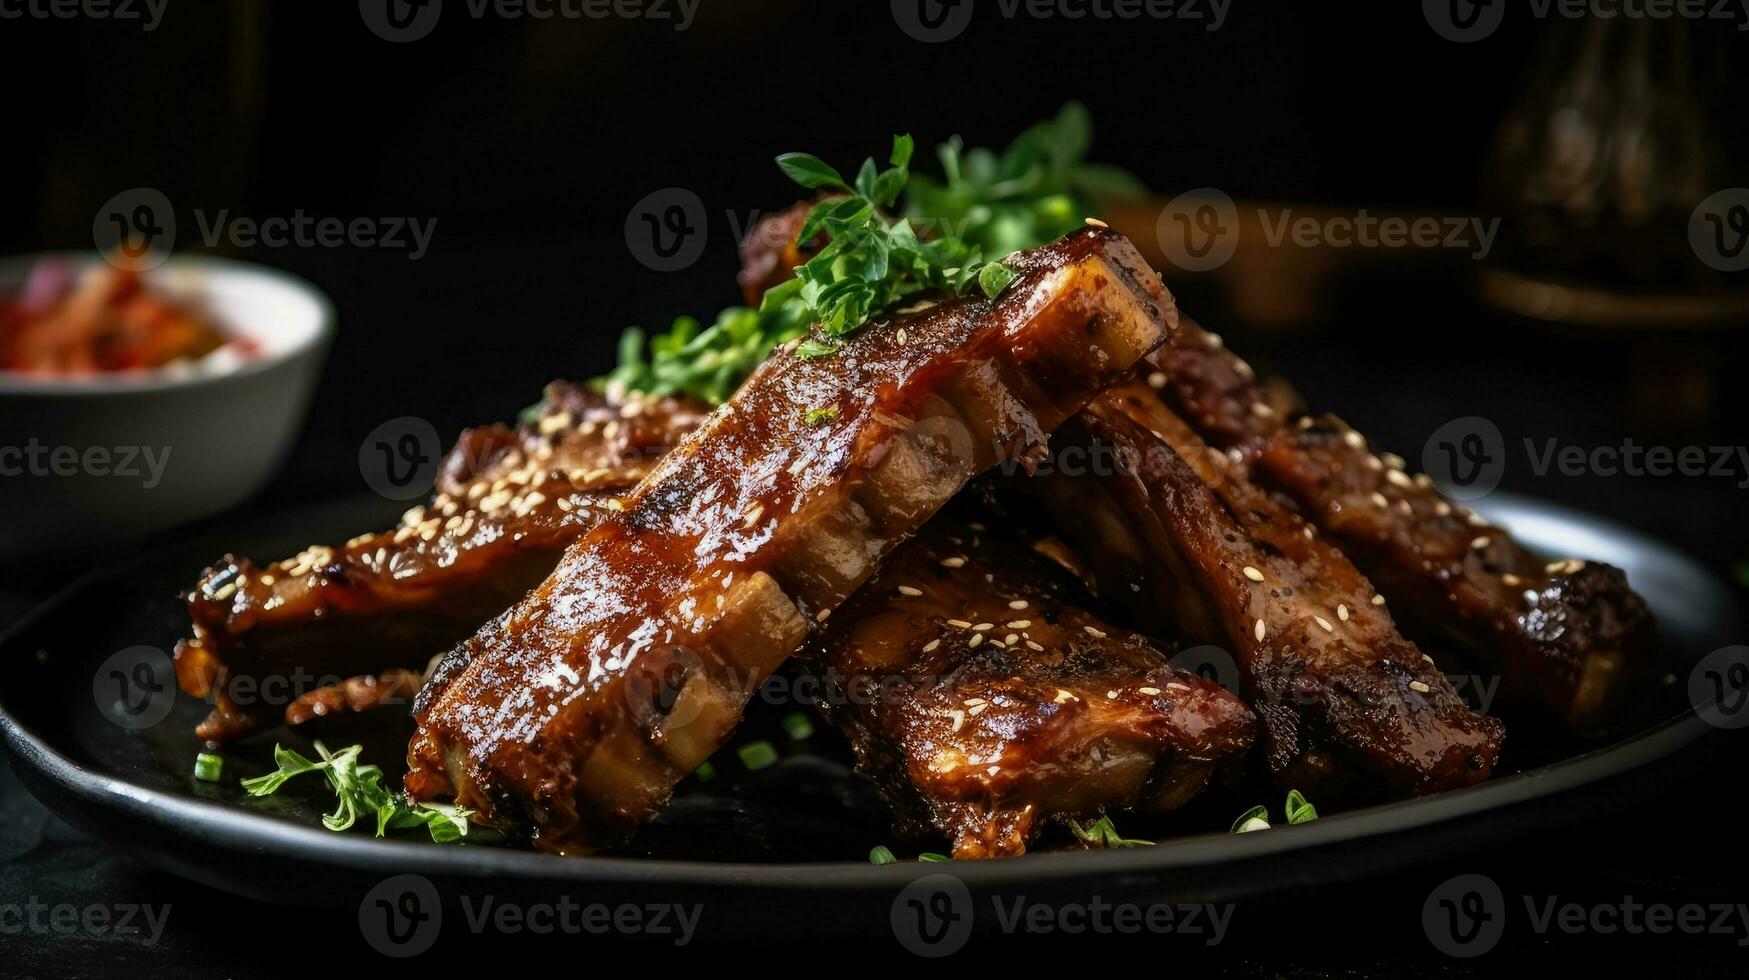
[1147,320,1656,732]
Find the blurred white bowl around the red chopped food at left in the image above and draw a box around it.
[0,256,334,553]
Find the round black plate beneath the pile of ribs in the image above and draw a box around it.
[0,494,1742,936]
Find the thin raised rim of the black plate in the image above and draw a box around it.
[0,492,1728,891]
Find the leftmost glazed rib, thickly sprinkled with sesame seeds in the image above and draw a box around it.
[177,383,703,740]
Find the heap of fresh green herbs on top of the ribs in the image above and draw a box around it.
[602,103,1142,403]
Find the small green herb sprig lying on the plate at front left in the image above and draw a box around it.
[243,742,470,844]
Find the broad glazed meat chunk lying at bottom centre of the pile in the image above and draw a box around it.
[803,518,1256,858]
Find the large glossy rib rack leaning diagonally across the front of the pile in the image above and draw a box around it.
[406,229,1175,852]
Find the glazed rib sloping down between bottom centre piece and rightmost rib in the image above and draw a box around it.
[1037,383,1504,802]
